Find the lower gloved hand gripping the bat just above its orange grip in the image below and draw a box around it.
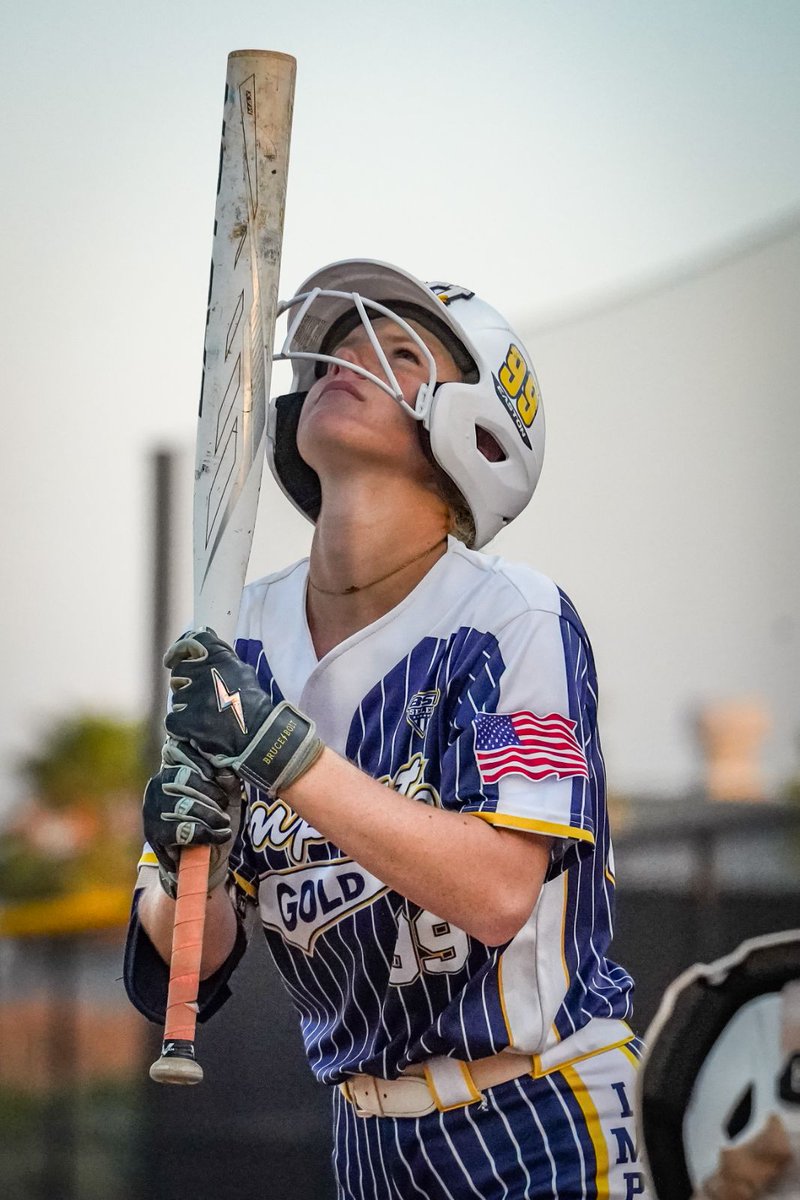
[142,739,242,899]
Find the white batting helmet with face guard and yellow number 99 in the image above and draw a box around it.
[267,259,545,547]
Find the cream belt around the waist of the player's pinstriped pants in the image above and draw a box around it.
[341,1050,534,1117]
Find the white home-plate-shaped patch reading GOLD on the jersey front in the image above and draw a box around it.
[258,858,389,954]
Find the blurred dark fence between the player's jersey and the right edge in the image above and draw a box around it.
[613,797,800,1033]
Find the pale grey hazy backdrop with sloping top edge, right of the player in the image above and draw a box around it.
[494,223,800,793]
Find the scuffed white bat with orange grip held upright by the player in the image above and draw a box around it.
[150,50,296,1084]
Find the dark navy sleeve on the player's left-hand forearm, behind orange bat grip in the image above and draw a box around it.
[124,868,247,1025]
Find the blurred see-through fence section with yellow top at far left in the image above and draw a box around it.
[0,888,142,1200]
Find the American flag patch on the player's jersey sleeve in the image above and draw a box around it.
[474,713,589,784]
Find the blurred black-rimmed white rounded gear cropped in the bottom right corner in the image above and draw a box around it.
[638,929,800,1200]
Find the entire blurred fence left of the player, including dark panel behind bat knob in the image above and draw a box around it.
[0,895,333,1200]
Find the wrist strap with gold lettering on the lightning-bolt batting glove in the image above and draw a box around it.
[233,701,323,796]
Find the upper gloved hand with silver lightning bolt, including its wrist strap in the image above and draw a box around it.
[164,629,323,796]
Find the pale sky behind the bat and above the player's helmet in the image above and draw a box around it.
[0,0,800,809]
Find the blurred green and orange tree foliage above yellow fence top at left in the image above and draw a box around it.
[0,714,149,900]
